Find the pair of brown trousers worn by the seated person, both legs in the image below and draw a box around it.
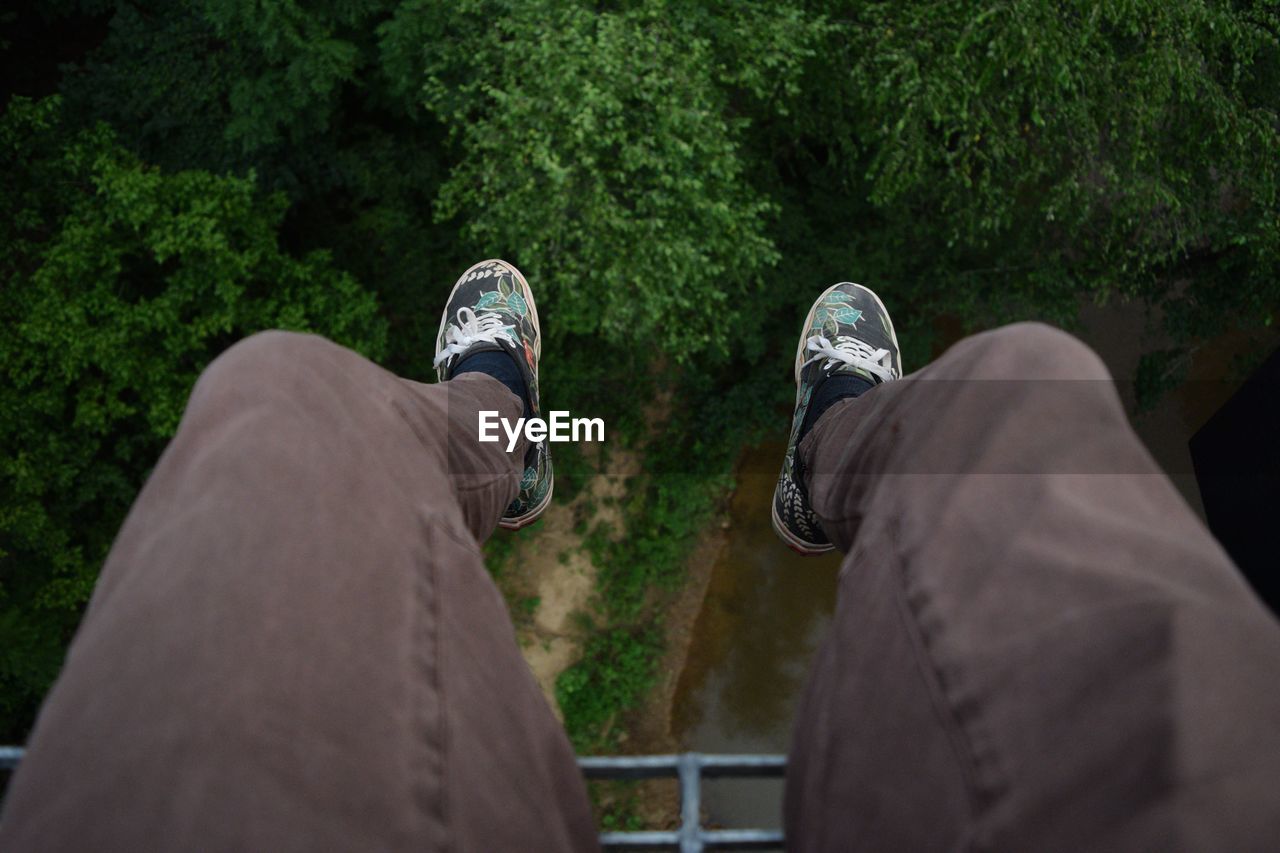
[0,325,1280,852]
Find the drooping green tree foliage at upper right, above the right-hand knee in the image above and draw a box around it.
[773,0,1280,356]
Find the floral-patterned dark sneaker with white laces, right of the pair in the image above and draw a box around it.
[773,282,902,555]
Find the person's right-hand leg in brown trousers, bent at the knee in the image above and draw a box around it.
[786,324,1280,850]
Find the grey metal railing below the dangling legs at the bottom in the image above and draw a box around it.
[0,747,787,853]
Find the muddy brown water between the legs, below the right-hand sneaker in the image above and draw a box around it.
[672,442,840,827]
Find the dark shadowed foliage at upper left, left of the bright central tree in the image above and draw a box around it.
[63,0,455,377]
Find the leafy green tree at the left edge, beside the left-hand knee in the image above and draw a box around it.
[0,100,385,736]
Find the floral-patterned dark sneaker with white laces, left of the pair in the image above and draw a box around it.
[435,260,554,530]
